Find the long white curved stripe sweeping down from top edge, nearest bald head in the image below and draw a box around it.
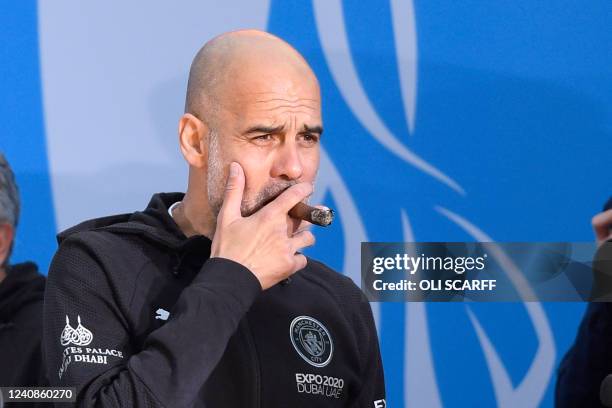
[313,0,465,194]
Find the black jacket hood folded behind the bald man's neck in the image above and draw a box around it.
[57,193,211,252]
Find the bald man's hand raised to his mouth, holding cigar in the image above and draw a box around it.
[211,162,314,290]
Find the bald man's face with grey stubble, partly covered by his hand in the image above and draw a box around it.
[208,70,322,216]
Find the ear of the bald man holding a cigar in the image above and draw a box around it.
[178,113,209,168]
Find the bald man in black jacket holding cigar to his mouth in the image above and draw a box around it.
[44,30,385,408]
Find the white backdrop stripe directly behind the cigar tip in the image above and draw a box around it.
[311,148,380,332]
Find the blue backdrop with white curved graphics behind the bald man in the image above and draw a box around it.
[0,0,612,407]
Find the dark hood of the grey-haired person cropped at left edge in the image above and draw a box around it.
[0,262,45,322]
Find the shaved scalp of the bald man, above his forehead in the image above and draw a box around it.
[185,30,318,126]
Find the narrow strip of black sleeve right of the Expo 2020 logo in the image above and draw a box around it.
[351,294,386,408]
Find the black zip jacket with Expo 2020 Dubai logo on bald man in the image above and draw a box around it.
[44,194,385,408]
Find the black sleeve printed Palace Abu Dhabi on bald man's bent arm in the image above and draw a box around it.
[43,239,261,407]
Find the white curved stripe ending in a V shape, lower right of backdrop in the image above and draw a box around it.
[436,206,555,408]
